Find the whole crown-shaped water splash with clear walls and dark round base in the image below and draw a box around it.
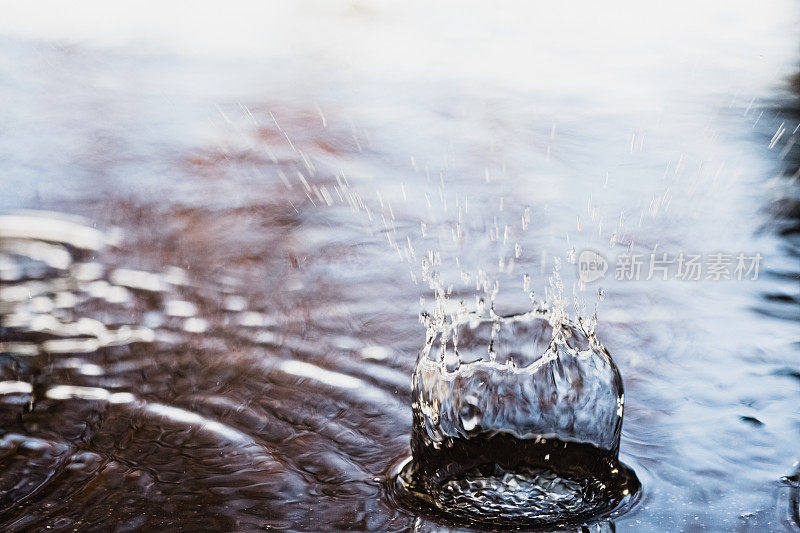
[393,308,639,527]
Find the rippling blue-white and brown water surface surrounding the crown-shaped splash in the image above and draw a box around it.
[0,1,800,531]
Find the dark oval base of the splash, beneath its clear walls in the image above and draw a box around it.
[392,433,640,530]
